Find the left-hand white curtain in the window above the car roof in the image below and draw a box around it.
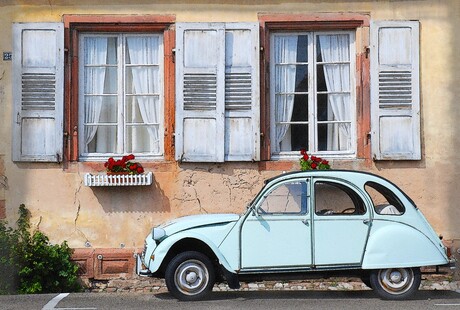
[274,36,298,152]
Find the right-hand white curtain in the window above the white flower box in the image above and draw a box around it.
[127,37,160,154]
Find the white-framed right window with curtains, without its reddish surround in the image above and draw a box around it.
[270,31,356,156]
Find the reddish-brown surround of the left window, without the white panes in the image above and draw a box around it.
[63,15,175,162]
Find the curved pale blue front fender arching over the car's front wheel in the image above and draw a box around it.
[149,231,235,273]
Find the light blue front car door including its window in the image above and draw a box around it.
[241,180,312,270]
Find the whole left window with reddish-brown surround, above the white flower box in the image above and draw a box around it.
[63,15,175,162]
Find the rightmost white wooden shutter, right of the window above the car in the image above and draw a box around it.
[371,21,421,160]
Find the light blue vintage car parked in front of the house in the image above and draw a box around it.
[136,170,449,300]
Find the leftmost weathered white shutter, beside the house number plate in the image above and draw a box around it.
[13,23,64,162]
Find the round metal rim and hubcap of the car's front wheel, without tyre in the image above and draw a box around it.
[174,260,209,295]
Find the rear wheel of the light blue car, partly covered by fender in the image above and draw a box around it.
[369,268,421,300]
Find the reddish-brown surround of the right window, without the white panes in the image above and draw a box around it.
[259,13,372,163]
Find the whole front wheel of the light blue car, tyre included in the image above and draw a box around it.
[165,251,215,301]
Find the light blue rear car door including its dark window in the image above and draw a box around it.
[312,178,371,267]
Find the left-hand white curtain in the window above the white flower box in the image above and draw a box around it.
[84,37,107,153]
